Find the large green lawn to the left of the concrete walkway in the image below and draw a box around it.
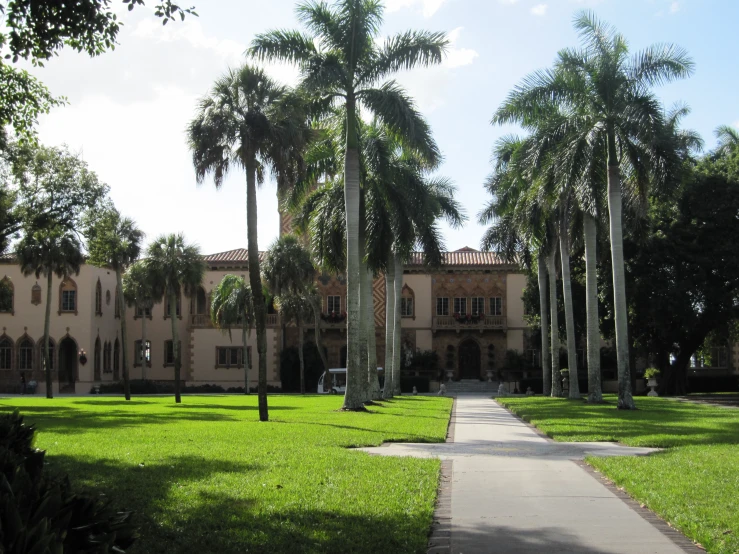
[0,396,451,554]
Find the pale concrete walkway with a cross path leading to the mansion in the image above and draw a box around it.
[362,395,700,554]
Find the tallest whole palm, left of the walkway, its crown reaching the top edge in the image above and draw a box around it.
[250,0,447,410]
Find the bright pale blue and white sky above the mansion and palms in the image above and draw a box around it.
[24,0,739,253]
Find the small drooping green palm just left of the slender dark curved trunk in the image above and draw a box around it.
[210,275,254,394]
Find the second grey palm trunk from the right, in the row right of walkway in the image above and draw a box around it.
[583,214,603,403]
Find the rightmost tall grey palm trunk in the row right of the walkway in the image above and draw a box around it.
[608,129,636,410]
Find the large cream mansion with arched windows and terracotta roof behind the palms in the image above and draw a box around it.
[0,243,538,393]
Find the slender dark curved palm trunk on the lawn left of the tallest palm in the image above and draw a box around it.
[246,152,269,421]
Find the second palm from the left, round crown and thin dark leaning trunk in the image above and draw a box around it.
[86,209,144,400]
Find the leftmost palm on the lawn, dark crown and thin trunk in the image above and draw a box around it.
[15,228,84,398]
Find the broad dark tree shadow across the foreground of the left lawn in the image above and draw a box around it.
[48,456,431,554]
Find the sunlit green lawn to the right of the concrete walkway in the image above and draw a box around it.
[498,396,739,553]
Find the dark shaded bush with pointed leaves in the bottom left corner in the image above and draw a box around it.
[0,411,137,554]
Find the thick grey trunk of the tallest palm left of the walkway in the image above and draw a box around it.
[342,94,366,410]
